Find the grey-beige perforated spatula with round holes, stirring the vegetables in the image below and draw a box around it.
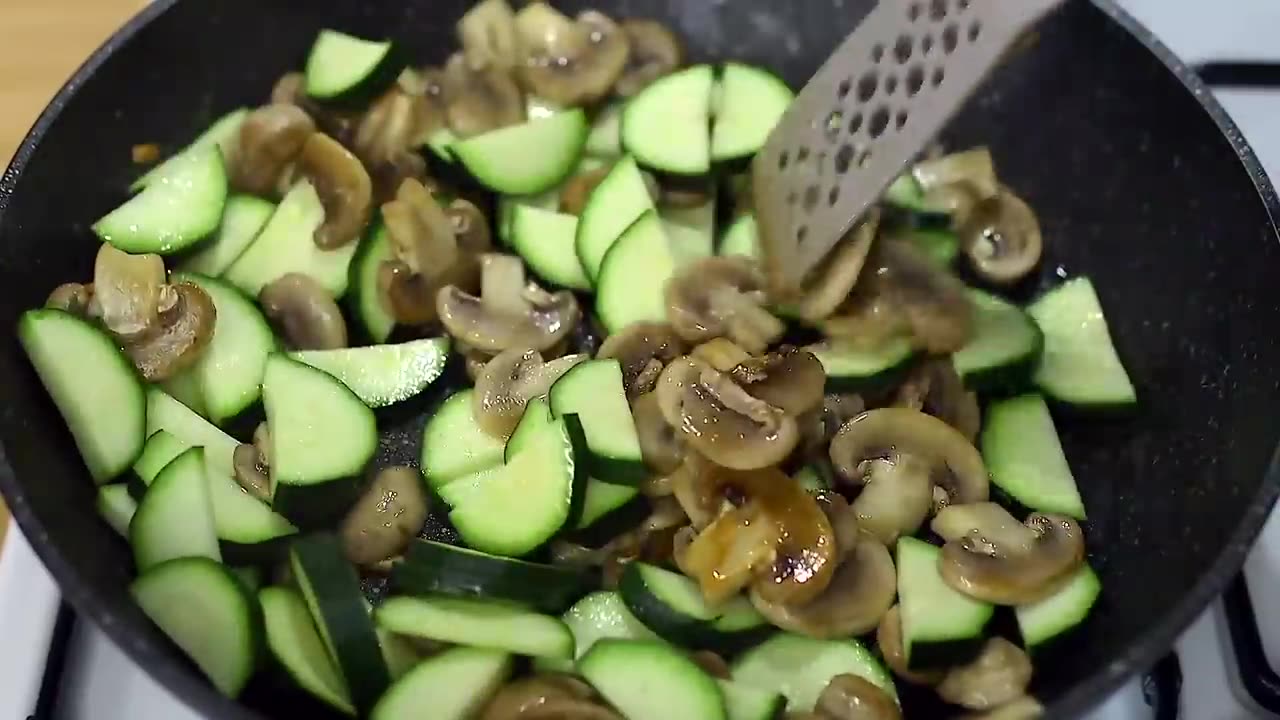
[753,0,1062,297]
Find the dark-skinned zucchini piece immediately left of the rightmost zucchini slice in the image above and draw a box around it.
[951,290,1044,392]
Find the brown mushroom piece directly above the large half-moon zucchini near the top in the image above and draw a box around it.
[443,54,525,138]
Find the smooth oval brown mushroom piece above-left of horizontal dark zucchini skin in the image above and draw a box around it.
[342,465,428,566]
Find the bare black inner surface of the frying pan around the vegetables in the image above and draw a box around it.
[0,0,1280,719]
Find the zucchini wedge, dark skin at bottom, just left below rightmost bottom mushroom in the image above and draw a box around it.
[897,538,995,669]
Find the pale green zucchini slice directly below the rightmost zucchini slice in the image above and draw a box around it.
[980,393,1085,520]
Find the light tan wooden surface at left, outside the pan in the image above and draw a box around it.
[0,0,146,541]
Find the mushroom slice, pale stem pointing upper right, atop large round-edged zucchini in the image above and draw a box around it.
[474,348,588,438]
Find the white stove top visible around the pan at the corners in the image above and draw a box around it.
[0,0,1280,720]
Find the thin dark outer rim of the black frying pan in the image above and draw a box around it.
[0,0,1280,720]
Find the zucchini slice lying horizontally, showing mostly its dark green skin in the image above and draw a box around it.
[390,539,593,612]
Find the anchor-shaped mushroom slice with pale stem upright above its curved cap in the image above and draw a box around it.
[435,254,581,352]
